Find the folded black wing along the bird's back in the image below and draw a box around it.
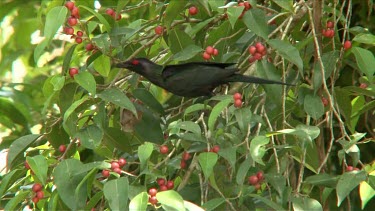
[162,62,236,79]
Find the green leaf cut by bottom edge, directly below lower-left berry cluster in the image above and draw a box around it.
[103,177,129,210]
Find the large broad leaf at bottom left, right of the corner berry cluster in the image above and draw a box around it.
[53,159,87,210]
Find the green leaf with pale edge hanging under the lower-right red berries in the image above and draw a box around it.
[336,171,367,206]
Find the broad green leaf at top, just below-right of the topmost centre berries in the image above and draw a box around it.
[243,8,269,40]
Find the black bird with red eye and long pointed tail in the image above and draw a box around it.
[115,58,291,97]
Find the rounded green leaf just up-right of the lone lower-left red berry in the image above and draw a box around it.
[76,125,104,149]
